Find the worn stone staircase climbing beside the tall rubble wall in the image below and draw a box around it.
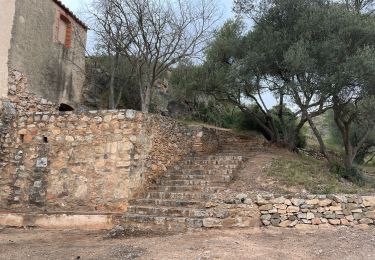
[121,134,255,232]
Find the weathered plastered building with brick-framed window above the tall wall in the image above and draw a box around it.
[0,0,87,108]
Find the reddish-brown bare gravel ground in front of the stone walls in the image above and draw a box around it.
[0,227,375,260]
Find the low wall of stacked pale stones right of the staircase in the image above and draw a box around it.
[256,195,375,227]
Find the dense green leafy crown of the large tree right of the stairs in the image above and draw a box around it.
[172,0,375,161]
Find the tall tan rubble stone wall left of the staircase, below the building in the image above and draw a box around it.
[0,106,223,212]
